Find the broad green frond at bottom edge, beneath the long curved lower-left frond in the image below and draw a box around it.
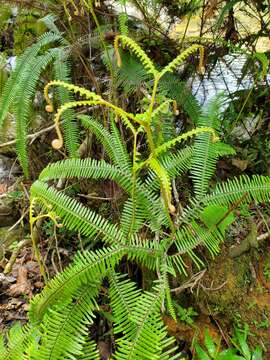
[38,284,99,360]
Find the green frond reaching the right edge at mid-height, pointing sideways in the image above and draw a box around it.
[204,175,270,205]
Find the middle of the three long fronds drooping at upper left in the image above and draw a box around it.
[13,52,53,177]
